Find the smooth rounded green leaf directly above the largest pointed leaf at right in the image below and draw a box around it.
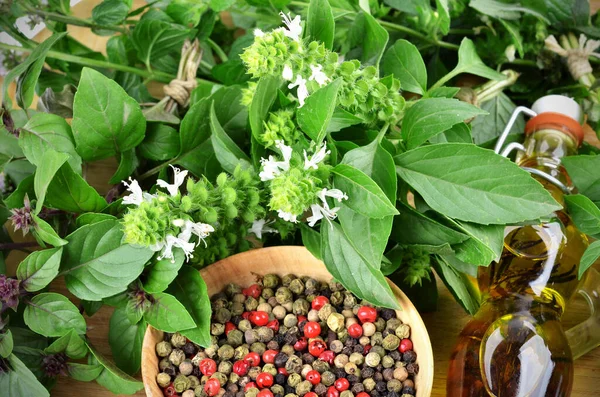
[402,98,486,149]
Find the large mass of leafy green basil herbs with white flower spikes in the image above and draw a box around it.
[0,0,600,396]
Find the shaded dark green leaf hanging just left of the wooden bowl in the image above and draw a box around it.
[108,308,147,375]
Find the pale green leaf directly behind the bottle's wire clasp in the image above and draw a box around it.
[471,92,525,145]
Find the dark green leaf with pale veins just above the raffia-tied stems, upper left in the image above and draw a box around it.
[132,19,190,69]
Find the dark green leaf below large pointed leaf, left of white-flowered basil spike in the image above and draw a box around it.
[47,164,108,213]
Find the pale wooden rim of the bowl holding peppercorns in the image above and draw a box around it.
[141,245,434,397]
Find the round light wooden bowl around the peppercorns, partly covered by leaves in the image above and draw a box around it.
[142,246,433,397]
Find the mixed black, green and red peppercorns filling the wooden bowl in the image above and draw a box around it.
[156,274,419,397]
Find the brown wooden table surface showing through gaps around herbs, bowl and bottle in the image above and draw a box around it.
[0,0,600,397]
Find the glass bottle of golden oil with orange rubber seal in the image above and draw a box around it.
[447,96,588,397]
